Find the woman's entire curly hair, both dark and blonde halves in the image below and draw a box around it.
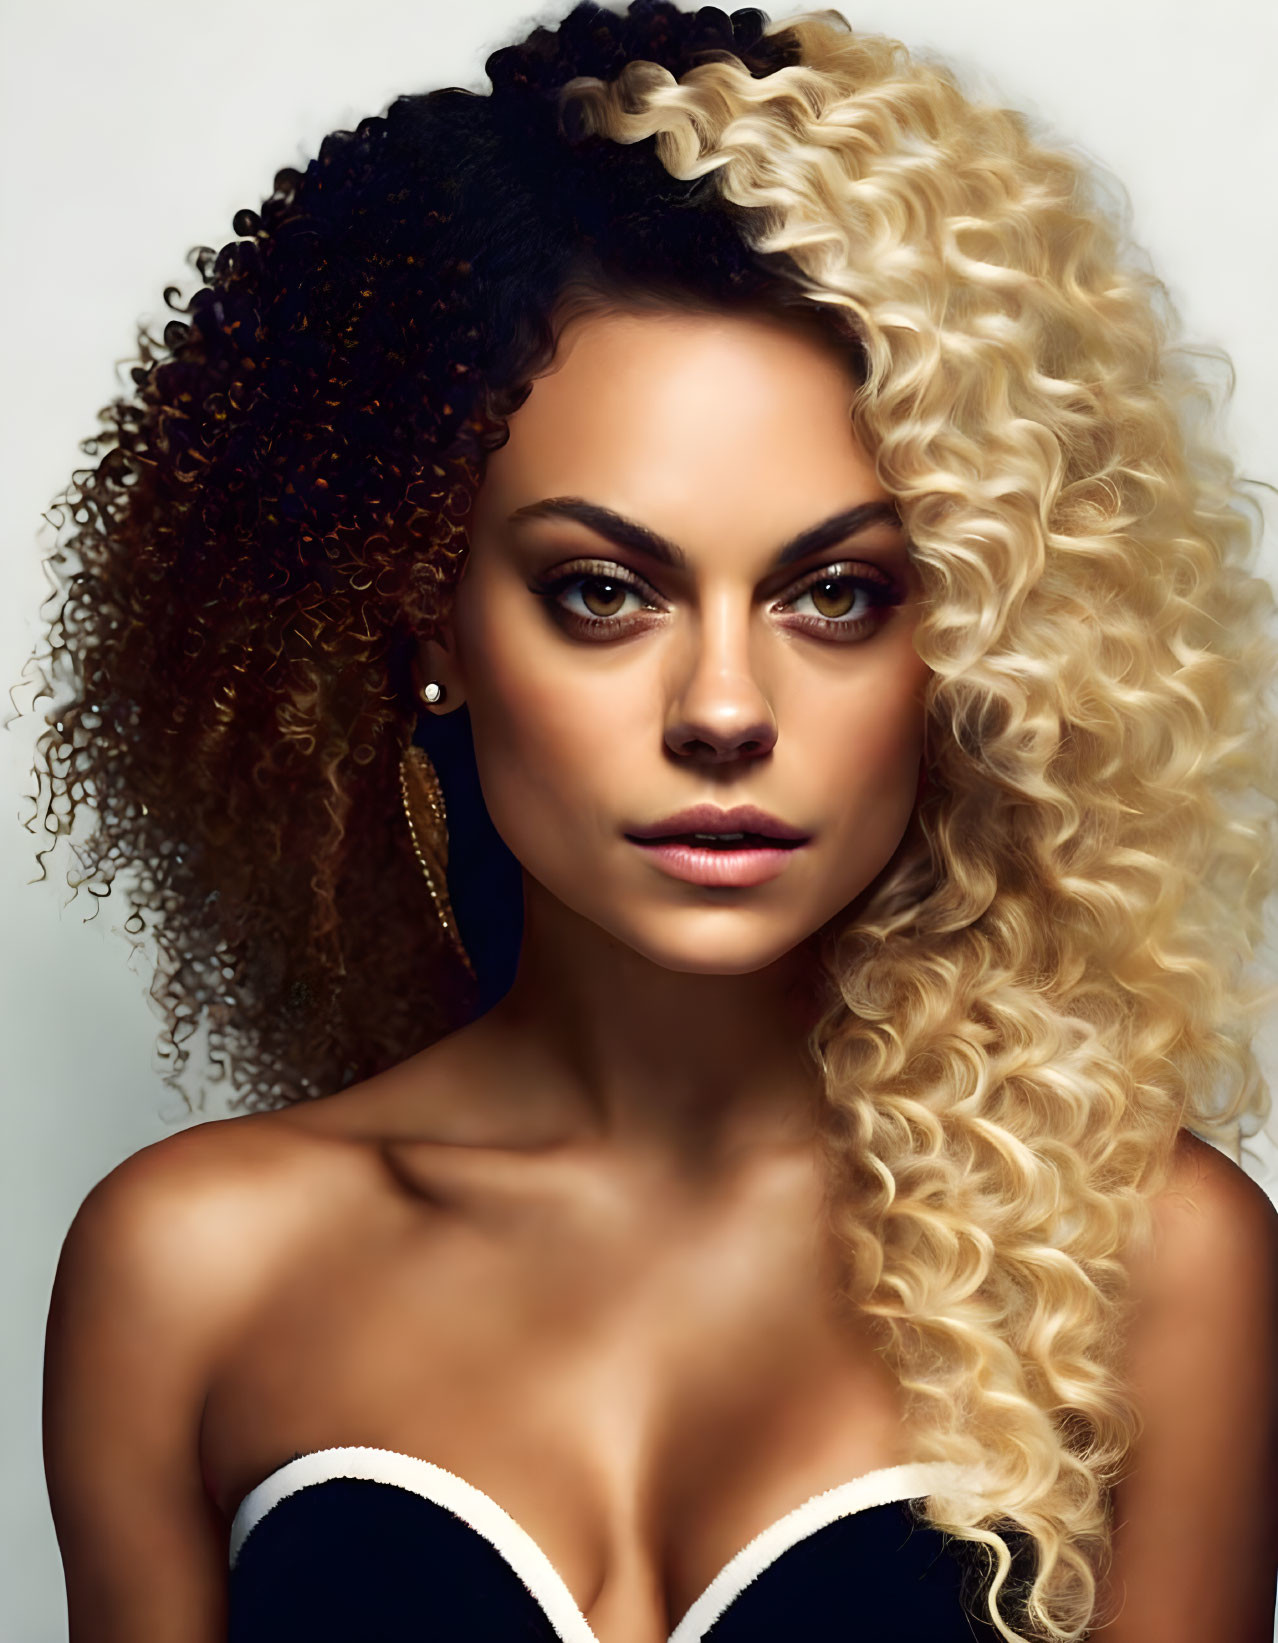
[17,0,1278,1640]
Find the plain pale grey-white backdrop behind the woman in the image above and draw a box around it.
[0,0,1278,1643]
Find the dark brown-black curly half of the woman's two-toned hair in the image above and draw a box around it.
[14,0,856,1109]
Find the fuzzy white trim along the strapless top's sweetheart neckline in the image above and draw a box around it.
[230,1444,968,1643]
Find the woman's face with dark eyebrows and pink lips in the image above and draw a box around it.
[422,312,928,974]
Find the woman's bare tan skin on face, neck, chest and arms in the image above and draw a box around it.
[44,312,1278,1643]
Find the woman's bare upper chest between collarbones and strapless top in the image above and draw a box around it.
[202,1150,910,1643]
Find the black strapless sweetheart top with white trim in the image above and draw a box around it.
[228,1447,997,1643]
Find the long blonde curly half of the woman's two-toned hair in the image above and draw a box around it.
[563,12,1278,1640]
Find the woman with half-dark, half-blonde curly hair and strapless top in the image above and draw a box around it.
[29,3,1278,1643]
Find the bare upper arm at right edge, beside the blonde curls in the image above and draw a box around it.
[1101,1132,1278,1643]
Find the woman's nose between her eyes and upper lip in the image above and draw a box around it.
[665,598,777,764]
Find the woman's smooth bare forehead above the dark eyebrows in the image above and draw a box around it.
[485,311,887,532]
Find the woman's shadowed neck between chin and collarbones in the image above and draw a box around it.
[485,881,821,1170]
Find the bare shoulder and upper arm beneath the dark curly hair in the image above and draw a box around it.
[43,1114,381,1643]
